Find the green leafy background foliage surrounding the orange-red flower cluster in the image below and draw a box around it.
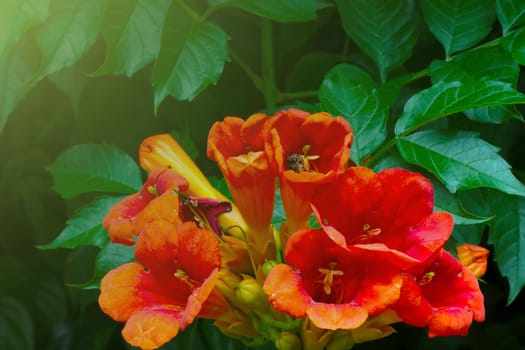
[0,0,525,350]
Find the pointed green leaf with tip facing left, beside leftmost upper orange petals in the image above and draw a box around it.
[39,197,123,249]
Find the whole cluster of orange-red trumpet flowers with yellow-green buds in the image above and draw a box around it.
[99,109,486,349]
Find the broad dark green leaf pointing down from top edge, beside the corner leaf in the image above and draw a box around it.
[419,0,496,57]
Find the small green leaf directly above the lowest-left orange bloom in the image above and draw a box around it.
[76,243,135,289]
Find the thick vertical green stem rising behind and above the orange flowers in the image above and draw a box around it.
[261,18,276,109]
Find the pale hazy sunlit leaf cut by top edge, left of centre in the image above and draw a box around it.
[93,0,170,77]
